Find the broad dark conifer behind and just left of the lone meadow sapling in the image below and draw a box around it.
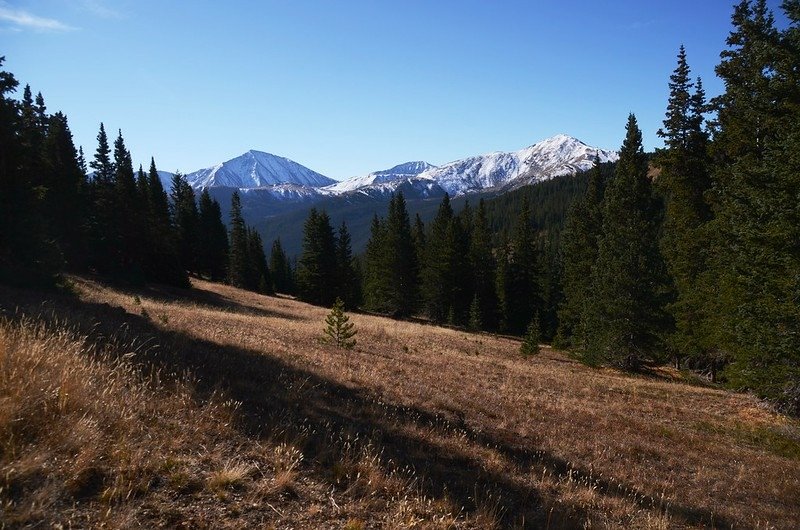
[297,208,338,306]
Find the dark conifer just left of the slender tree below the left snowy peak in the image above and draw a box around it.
[197,188,230,281]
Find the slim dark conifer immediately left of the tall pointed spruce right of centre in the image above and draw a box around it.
[557,162,605,349]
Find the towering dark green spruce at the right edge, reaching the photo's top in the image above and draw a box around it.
[704,1,800,412]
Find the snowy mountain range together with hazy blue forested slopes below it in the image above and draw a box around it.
[180,134,618,255]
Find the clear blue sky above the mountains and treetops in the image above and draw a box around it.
[0,0,780,179]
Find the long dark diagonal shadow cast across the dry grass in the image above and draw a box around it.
[0,287,731,528]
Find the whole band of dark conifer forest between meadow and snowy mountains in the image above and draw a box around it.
[0,0,800,413]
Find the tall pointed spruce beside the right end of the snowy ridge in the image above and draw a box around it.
[583,114,666,369]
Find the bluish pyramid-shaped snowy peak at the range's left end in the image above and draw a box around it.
[186,150,336,189]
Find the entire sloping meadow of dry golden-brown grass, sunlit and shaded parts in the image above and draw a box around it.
[0,278,800,530]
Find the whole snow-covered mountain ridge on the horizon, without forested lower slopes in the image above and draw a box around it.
[181,134,618,202]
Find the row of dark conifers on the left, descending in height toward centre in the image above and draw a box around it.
[0,58,293,293]
